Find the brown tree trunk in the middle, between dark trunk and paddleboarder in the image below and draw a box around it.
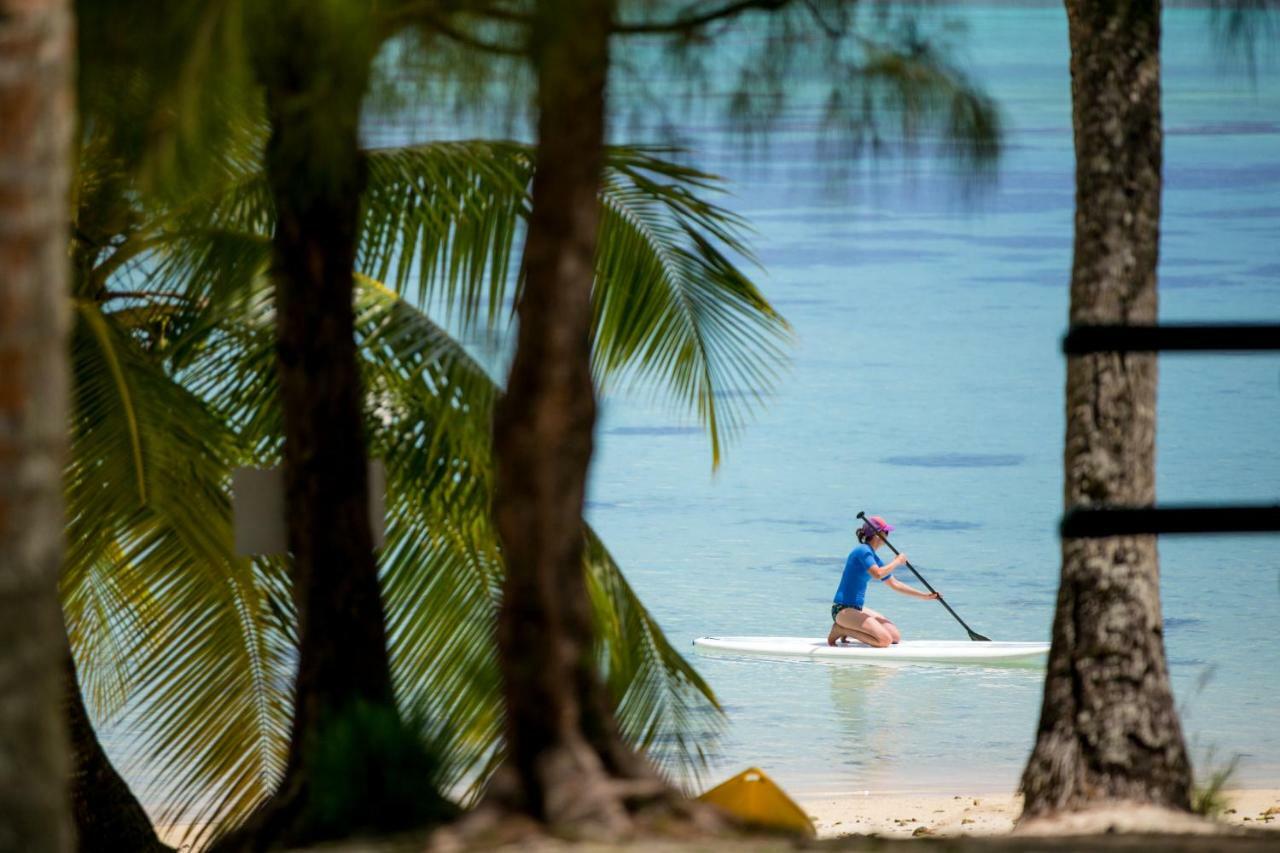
[494,0,666,833]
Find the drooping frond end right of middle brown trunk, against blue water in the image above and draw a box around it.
[594,147,788,465]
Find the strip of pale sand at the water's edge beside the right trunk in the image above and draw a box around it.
[796,788,1280,838]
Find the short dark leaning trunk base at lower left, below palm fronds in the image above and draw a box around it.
[63,647,173,853]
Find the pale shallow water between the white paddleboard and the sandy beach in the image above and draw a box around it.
[695,652,1043,794]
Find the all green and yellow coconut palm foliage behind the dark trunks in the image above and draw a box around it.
[70,136,786,840]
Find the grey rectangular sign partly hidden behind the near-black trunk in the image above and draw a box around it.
[232,459,387,557]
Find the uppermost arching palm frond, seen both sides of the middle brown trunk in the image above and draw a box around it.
[358,141,788,465]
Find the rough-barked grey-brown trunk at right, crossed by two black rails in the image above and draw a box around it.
[1023,0,1190,816]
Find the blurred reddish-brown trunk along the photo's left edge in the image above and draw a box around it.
[0,0,74,853]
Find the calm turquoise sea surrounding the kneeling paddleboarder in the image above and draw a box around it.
[578,6,1280,793]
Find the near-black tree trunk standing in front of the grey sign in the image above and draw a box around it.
[218,9,453,849]
